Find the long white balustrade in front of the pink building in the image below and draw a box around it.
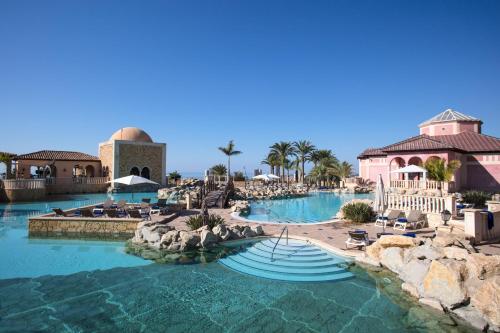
[387,194,456,215]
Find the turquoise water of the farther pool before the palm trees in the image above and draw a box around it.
[244,192,373,224]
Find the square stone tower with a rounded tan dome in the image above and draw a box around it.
[99,127,167,185]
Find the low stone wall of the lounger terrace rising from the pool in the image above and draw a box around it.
[28,216,141,238]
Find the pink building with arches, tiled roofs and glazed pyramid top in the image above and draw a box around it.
[358,109,500,192]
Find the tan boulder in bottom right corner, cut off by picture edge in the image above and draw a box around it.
[471,275,500,327]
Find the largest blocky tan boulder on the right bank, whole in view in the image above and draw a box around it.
[422,259,468,308]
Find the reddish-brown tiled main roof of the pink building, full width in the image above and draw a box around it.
[358,132,500,158]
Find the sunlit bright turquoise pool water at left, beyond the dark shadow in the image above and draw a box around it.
[0,193,156,279]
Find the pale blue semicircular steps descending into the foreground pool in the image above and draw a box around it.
[219,238,353,282]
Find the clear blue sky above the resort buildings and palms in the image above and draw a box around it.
[0,0,500,175]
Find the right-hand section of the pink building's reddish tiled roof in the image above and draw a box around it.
[434,132,500,153]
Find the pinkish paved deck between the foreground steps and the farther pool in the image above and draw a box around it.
[169,209,500,256]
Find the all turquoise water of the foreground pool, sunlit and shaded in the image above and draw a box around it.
[0,193,473,333]
